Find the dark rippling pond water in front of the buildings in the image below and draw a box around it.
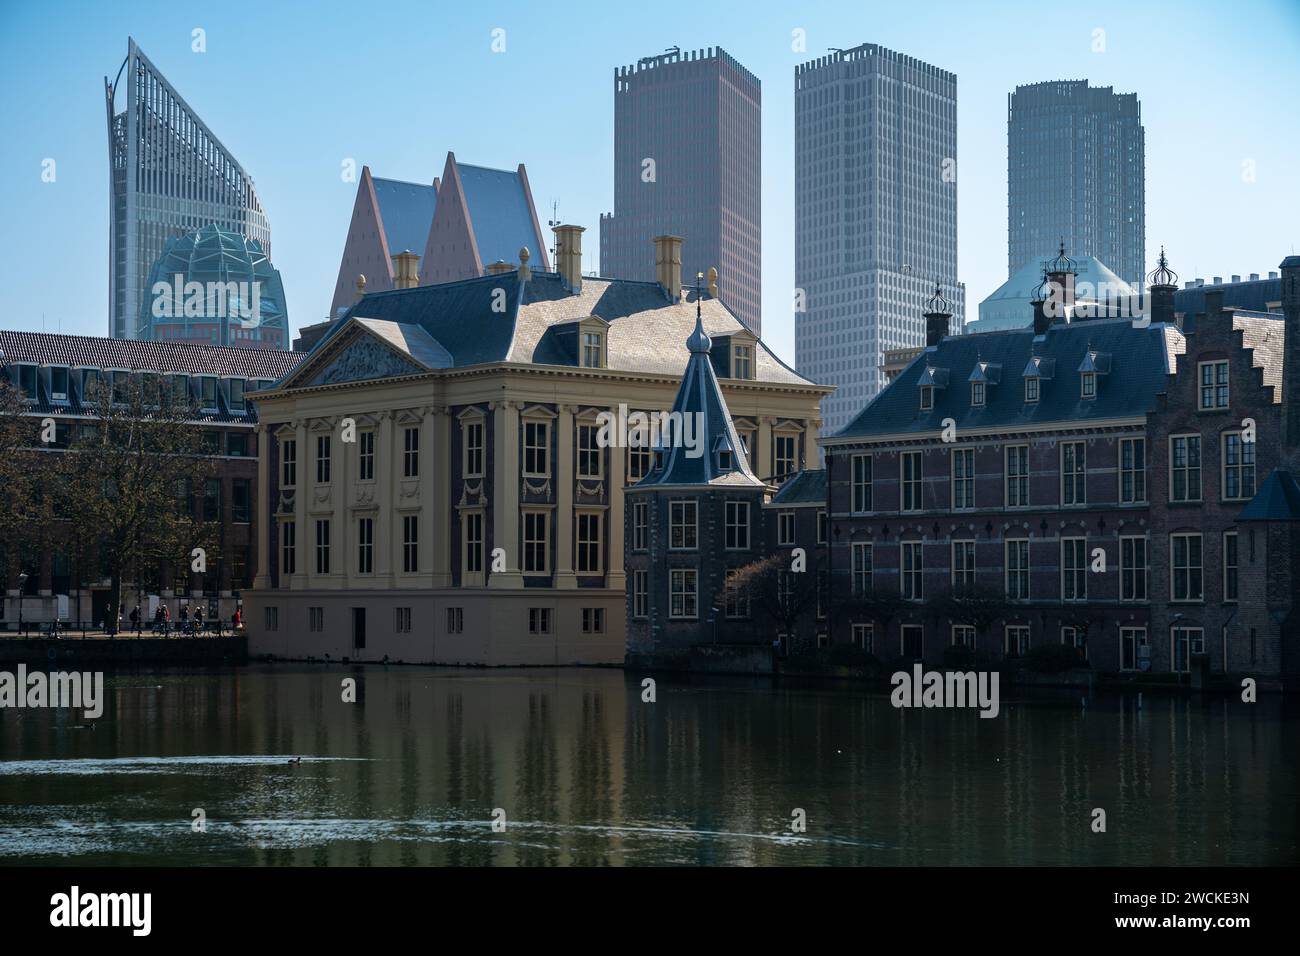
[0,665,1300,866]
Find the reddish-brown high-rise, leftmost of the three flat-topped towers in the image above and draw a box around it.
[601,47,763,336]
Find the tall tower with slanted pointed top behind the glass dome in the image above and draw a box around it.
[104,39,270,338]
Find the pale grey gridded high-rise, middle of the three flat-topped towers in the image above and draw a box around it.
[794,43,966,433]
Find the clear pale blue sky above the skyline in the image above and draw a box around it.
[0,0,1300,360]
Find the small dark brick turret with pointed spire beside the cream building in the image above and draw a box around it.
[623,273,771,663]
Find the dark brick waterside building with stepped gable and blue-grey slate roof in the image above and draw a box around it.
[806,247,1300,674]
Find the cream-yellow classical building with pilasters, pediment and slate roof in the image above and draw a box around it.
[244,226,831,665]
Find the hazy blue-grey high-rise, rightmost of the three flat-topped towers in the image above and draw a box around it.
[1006,79,1147,289]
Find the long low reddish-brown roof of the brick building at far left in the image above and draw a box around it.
[0,329,304,378]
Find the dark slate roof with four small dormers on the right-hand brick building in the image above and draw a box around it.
[827,319,1186,442]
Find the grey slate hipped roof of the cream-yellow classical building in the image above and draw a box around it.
[293,271,814,386]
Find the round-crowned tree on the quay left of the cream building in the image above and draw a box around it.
[64,372,216,631]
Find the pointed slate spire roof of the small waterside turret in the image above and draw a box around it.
[636,302,766,488]
